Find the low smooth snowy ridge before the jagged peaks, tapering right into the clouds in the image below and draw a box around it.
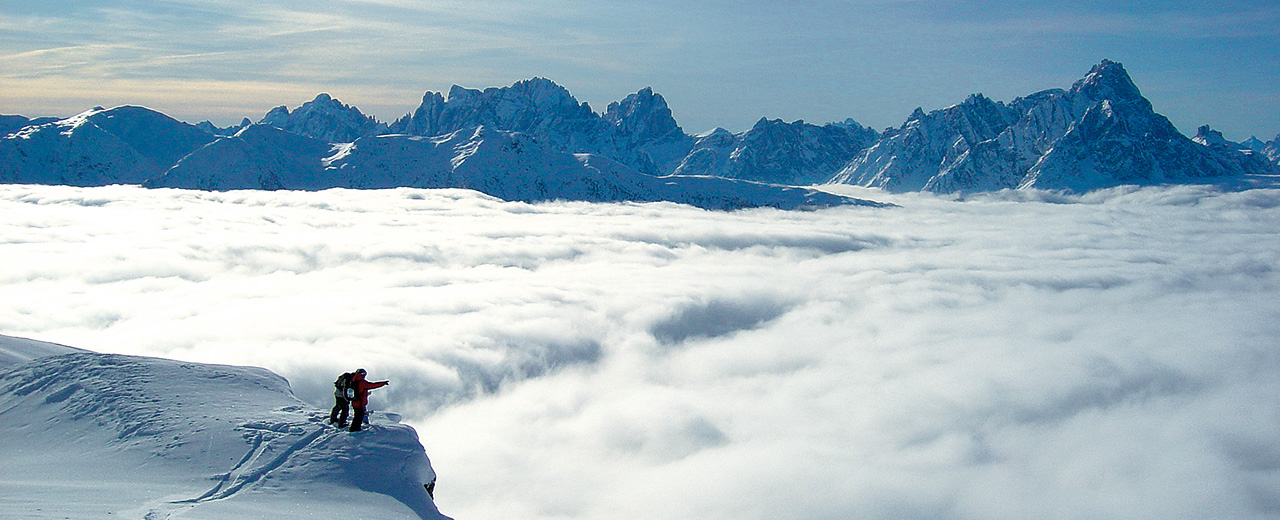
[145,124,870,209]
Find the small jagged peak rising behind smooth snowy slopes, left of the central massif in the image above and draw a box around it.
[259,93,387,142]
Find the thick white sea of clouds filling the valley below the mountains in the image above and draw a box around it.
[0,181,1280,520]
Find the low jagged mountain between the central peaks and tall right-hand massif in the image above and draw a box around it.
[675,118,878,184]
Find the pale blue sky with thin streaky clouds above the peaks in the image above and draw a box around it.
[0,0,1280,140]
